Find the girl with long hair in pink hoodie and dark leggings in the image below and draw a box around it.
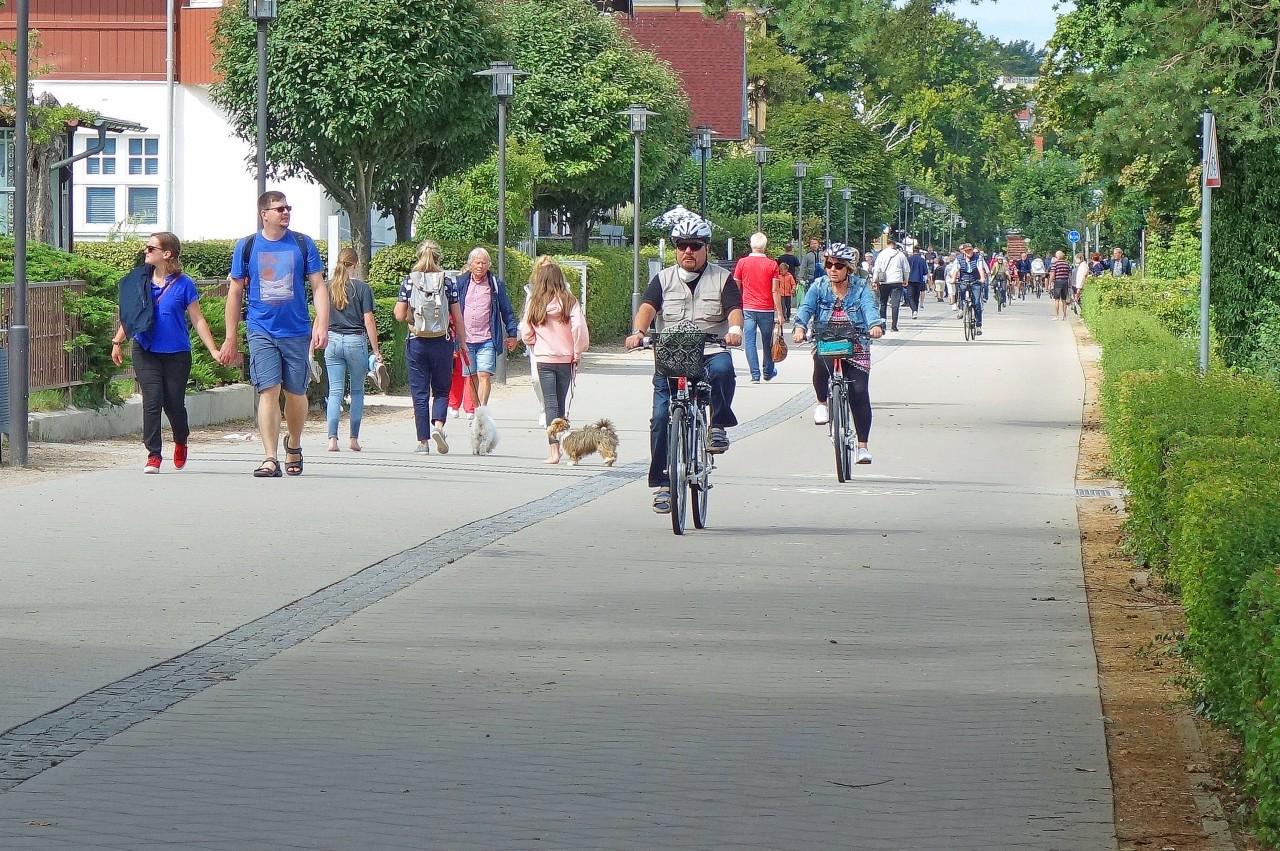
[520,255,591,465]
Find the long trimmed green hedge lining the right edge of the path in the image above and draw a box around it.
[1084,270,1280,842]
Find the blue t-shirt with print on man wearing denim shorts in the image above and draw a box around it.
[232,230,324,337]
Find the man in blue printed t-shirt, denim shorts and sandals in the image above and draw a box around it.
[218,191,329,479]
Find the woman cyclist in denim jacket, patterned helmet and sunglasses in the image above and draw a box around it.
[792,242,884,465]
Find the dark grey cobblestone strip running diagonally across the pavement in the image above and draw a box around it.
[0,392,809,793]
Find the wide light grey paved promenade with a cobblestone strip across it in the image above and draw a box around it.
[0,301,1115,851]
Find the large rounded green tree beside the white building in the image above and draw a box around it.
[211,0,500,264]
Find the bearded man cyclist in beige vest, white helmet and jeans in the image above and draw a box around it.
[627,216,742,514]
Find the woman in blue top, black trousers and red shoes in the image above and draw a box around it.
[111,230,219,472]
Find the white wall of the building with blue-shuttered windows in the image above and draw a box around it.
[36,81,337,239]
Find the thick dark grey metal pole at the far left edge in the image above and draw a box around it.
[9,0,31,467]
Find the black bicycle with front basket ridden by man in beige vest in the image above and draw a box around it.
[653,322,724,535]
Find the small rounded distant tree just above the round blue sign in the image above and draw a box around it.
[1000,151,1089,253]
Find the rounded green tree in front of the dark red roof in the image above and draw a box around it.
[498,0,690,251]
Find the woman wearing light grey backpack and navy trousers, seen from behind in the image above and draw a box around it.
[396,239,462,454]
